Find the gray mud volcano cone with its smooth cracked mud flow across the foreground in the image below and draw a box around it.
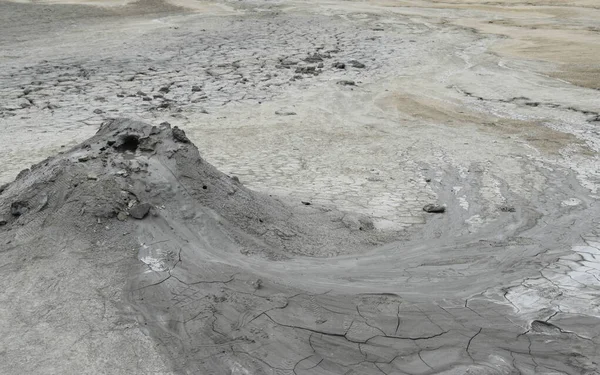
[0,120,600,374]
